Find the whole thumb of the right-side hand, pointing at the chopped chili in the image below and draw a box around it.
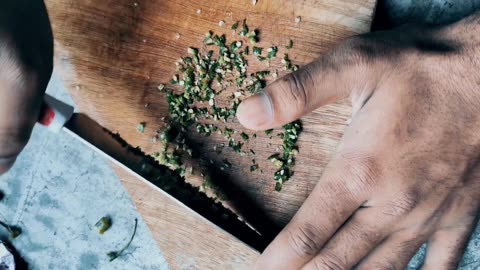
[237,38,381,130]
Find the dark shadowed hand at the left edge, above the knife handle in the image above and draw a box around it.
[0,0,53,174]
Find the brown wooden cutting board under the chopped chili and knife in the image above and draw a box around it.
[46,0,376,269]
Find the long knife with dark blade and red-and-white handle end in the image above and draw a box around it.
[38,95,271,251]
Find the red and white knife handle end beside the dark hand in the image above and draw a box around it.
[38,94,73,133]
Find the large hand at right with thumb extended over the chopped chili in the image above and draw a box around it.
[237,12,480,270]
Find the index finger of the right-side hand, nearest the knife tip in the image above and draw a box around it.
[255,158,374,270]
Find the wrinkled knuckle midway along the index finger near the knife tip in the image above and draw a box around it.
[288,224,324,257]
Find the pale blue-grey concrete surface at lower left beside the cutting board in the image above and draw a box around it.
[0,74,168,269]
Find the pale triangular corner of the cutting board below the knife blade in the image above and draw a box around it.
[115,168,258,269]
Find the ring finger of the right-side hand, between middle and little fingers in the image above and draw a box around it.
[355,230,428,270]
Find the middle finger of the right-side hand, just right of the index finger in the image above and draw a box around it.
[302,208,392,270]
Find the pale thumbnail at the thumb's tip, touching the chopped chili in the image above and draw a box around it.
[237,92,273,129]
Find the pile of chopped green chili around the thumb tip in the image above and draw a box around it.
[156,19,301,190]
